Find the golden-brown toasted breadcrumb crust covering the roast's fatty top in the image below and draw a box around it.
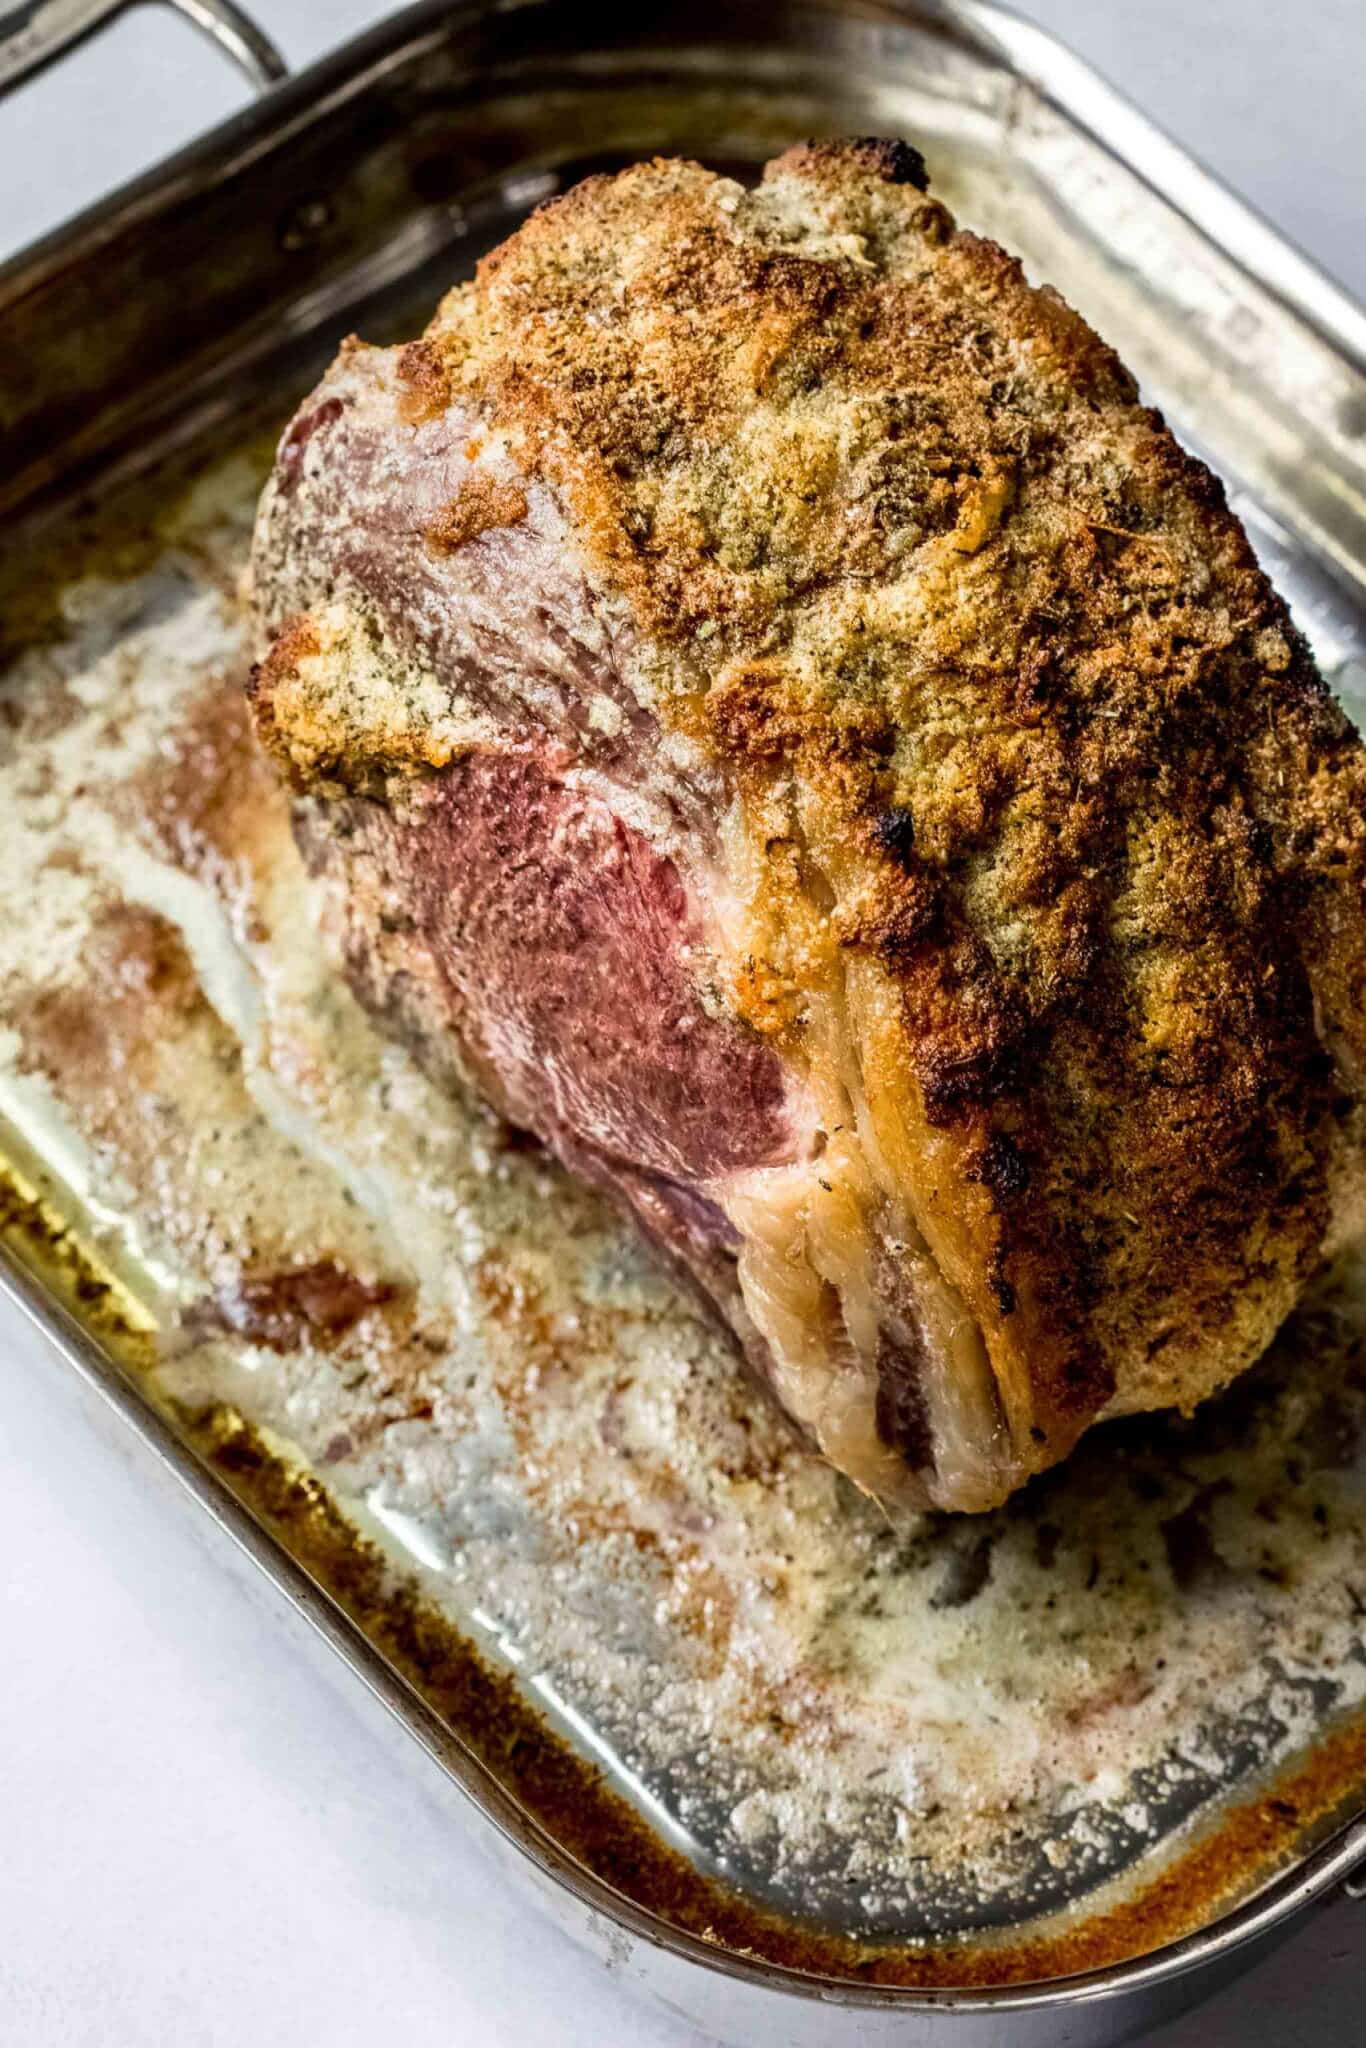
[258,141,1366,1507]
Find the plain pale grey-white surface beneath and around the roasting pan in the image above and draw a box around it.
[0,0,1366,2048]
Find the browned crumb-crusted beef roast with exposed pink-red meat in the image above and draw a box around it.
[250,141,1366,1509]
